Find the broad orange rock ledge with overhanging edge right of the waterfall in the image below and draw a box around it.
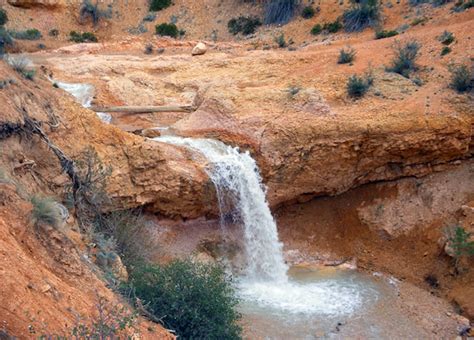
[38,22,473,210]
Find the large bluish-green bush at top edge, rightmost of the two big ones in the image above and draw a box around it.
[342,0,380,32]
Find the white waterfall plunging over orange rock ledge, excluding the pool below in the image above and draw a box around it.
[154,136,288,282]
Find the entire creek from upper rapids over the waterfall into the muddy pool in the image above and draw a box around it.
[65,82,434,339]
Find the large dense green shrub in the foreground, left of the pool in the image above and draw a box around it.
[127,260,241,339]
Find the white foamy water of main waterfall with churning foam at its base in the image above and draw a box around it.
[154,136,377,316]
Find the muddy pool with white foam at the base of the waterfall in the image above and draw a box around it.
[238,267,432,339]
